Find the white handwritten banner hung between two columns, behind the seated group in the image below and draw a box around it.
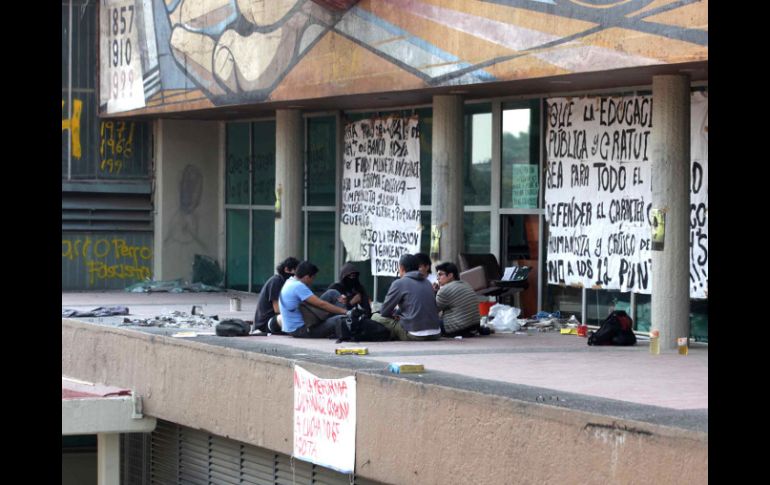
[340,117,421,276]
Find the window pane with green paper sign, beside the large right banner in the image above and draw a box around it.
[500,100,540,209]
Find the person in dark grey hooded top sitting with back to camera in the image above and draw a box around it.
[371,254,441,340]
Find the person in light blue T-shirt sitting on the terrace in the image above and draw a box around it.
[277,261,347,338]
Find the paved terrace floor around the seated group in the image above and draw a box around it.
[62,291,708,434]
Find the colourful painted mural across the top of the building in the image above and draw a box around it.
[100,0,708,114]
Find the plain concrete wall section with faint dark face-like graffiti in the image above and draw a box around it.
[154,120,219,281]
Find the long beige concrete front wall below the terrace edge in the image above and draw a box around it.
[62,320,708,485]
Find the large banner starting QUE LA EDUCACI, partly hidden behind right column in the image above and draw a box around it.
[545,92,708,298]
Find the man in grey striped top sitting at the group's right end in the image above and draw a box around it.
[436,262,481,337]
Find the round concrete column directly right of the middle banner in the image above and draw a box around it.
[431,96,464,264]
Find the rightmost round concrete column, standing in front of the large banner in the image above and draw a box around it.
[652,75,690,349]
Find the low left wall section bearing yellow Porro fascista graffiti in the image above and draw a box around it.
[61,235,152,288]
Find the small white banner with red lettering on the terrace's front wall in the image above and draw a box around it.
[293,366,356,473]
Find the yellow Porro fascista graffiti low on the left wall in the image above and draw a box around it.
[61,237,152,285]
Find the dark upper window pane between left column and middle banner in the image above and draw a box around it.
[307,116,337,208]
